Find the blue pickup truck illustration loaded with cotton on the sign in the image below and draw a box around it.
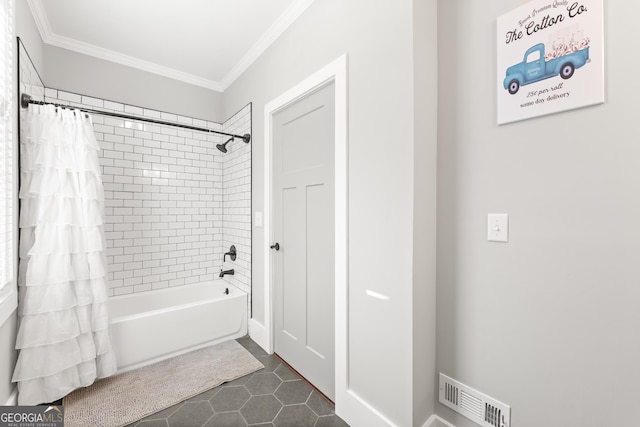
[504,39,589,95]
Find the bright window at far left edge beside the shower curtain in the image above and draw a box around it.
[0,0,15,325]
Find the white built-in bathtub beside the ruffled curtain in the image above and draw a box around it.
[109,280,247,373]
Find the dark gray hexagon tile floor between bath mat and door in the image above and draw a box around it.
[128,337,348,427]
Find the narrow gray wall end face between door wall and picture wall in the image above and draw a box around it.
[412,0,438,425]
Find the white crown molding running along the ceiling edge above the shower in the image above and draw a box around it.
[27,0,314,92]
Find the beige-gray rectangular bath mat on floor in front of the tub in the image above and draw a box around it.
[62,340,264,427]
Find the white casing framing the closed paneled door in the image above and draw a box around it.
[250,54,348,410]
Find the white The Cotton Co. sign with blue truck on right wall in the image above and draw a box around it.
[497,0,604,125]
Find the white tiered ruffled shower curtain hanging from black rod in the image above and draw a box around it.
[13,105,116,405]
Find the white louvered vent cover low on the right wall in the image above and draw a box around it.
[440,373,511,427]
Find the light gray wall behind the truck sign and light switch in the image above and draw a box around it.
[436,0,640,427]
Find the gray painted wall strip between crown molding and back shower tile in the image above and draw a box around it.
[44,45,224,123]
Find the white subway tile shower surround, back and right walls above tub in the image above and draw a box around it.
[45,88,251,304]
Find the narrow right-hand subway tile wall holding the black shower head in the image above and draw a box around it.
[222,104,251,313]
